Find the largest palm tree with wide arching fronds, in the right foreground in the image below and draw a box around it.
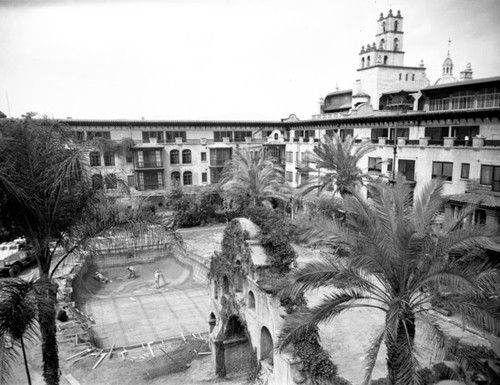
[279,180,500,385]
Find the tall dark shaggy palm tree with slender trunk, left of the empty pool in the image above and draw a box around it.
[0,115,183,385]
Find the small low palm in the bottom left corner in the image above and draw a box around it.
[0,278,50,384]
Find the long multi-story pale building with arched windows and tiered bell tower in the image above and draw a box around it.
[56,11,500,222]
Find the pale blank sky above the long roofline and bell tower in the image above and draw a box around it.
[0,0,500,121]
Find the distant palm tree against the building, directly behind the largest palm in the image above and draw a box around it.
[303,132,373,196]
